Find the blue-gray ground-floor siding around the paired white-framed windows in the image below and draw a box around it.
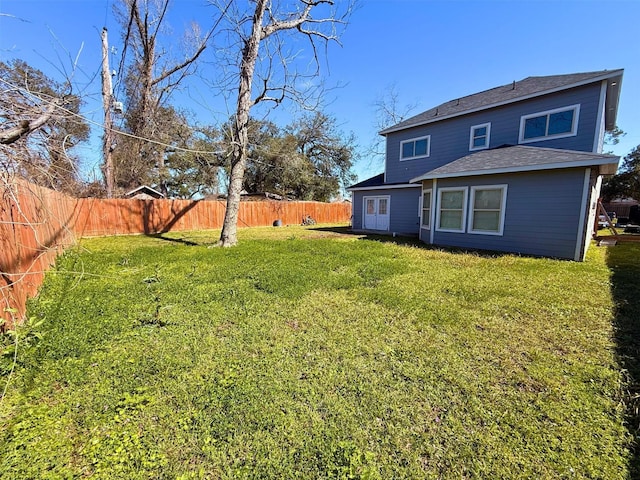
[423,168,585,259]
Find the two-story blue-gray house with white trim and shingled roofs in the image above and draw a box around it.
[349,70,623,261]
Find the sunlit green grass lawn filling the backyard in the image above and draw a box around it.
[0,227,636,479]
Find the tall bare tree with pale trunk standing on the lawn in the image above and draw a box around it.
[212,0,354,247]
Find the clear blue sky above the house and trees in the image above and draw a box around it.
[0,0,640,185]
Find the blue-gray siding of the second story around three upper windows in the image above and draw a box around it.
[385,83,600,183]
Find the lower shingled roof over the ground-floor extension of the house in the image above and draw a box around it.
[410,145,620,182]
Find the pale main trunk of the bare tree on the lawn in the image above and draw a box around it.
[218,0,267,247]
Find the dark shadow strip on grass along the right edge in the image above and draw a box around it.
[607,243,640,478]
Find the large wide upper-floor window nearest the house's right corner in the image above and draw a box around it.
[520,105,580,143]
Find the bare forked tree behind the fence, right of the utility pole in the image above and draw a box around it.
[115,0,213,193]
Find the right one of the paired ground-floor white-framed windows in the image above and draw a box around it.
[469,185,507,235]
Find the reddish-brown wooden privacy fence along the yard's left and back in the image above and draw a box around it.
[0,177,351,322]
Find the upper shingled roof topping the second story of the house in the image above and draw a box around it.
[380,69,624,135]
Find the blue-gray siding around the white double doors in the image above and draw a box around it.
[351,186,421,235]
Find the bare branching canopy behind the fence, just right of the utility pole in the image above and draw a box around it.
[113,0,212,194]
